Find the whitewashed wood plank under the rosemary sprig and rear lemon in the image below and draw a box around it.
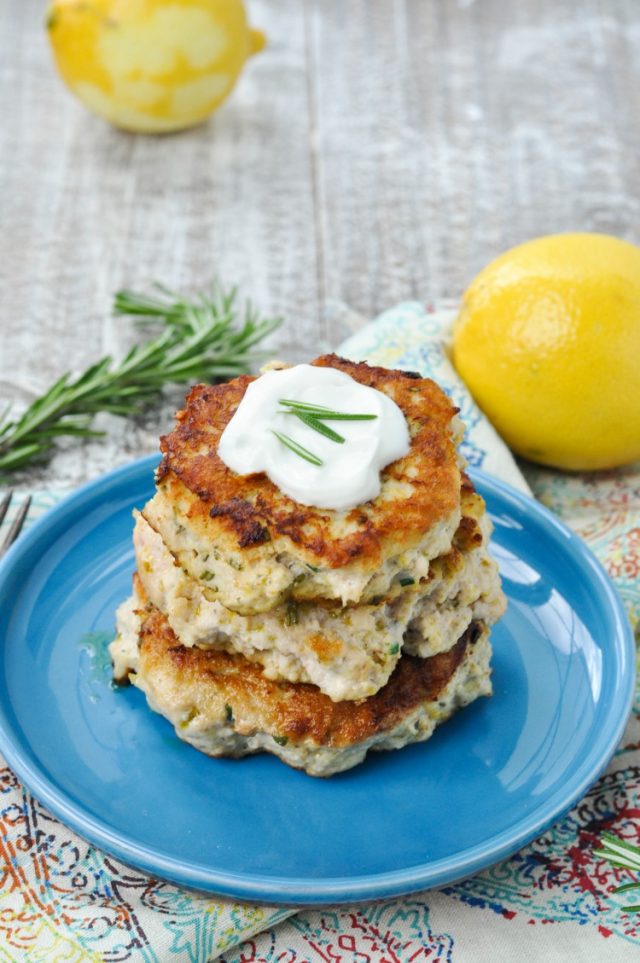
[0,0,320,483]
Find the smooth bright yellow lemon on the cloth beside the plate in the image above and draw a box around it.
[453,234,640,470]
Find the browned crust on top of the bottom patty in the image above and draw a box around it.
[140,609,480,748]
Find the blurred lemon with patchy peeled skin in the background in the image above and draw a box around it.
[47,0,265,133]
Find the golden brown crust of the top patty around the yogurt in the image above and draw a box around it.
[157,355,460,568]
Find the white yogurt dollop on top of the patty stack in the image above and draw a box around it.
[218,364,410,510]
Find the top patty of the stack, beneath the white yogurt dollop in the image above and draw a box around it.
[145,355,460,612]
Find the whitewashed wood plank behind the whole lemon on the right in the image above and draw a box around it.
[308,0,640,308]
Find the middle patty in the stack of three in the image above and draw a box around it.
[134,472,504,701]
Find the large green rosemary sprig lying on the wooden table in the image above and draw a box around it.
[0,282,281,477]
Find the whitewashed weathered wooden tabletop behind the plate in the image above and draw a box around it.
[0,0,640,488]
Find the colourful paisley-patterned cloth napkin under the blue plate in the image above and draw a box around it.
[0,302,640,963]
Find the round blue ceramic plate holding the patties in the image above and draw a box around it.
[0,458,634,903]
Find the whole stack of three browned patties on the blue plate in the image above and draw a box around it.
[111,355,504,776]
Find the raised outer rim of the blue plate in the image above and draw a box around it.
[0,454,636,906]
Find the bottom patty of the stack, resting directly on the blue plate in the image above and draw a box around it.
[111,582,491,776]
